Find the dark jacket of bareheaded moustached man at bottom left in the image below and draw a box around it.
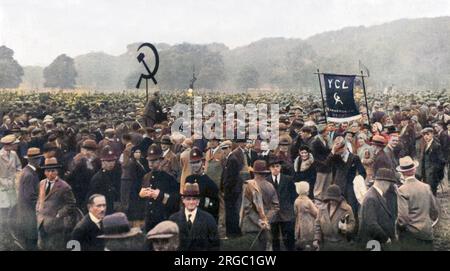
[72,214,105,251]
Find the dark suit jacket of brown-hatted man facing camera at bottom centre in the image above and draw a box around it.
[170,208,220,251]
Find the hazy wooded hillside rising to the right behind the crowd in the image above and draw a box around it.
[24,17,450,90]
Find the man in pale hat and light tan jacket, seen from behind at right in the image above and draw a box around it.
[397,156,439,250]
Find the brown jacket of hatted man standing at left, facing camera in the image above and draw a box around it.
[36,179,75,233]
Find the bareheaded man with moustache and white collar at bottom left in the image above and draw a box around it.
[72,194,106,251]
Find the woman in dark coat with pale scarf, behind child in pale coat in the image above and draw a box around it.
[294,145,317,199]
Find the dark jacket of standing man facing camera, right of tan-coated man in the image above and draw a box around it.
[266,174,298,222]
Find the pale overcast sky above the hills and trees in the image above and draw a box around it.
[0,0,450,66]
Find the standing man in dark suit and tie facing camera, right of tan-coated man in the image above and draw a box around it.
[267,157,297,251]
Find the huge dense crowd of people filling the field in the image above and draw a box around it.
[0,88,450,251]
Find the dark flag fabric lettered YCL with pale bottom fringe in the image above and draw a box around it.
[323,74,361,122]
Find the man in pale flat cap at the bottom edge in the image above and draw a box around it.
[147,220,180,251]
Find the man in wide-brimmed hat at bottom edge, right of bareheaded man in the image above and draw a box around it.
[97,212,145,251]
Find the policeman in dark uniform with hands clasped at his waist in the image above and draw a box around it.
[139,144,179,232]
